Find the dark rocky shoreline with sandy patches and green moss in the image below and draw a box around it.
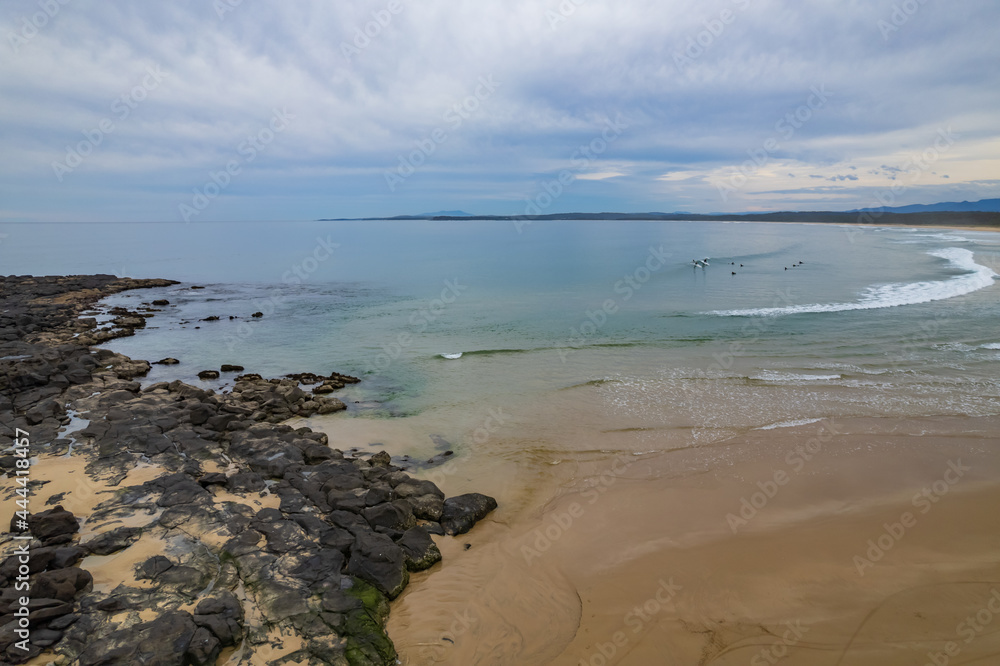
[0,275,496,666]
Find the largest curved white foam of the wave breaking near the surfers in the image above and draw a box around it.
[709,247,997,317]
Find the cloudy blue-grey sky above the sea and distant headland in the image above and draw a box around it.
[0,0,1000,222]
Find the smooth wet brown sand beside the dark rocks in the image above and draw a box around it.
[374,418,1000,666]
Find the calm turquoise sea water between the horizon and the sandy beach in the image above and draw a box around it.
[0,221,1000,454]
